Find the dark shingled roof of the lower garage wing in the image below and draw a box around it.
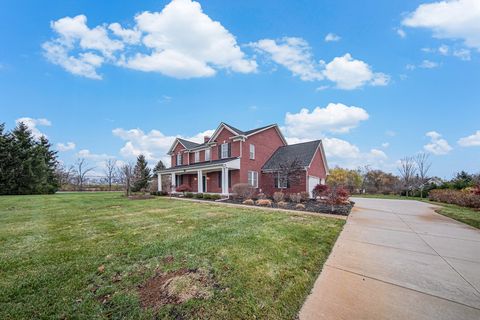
[262,140,323,170]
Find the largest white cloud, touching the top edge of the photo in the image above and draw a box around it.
[43,0,257,79]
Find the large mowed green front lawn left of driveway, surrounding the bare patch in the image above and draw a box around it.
[0,193,344,319]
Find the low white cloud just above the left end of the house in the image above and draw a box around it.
[112,128,214,164]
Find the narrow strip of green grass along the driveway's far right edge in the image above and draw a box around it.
[354,194,480,229]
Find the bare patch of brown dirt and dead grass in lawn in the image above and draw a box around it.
[138,269,214,309]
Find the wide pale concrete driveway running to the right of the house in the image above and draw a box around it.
[299,198,480,320]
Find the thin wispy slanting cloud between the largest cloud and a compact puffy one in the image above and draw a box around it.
[250,37,324,81]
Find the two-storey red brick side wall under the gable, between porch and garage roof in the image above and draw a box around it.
[239,128,285,187]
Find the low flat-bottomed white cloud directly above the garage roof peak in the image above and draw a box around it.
[285,103,369,138]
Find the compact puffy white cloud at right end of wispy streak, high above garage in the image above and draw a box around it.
[324,53,390,90]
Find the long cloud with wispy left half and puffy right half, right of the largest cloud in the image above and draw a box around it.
[250,37,390,90]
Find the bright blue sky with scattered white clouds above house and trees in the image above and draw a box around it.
[0,0,480,178]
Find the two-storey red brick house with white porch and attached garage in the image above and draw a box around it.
[158,122,328,195]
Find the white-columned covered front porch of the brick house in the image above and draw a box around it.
[158,159,240,195]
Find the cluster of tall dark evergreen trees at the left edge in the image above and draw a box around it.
[0,123,59,195]
